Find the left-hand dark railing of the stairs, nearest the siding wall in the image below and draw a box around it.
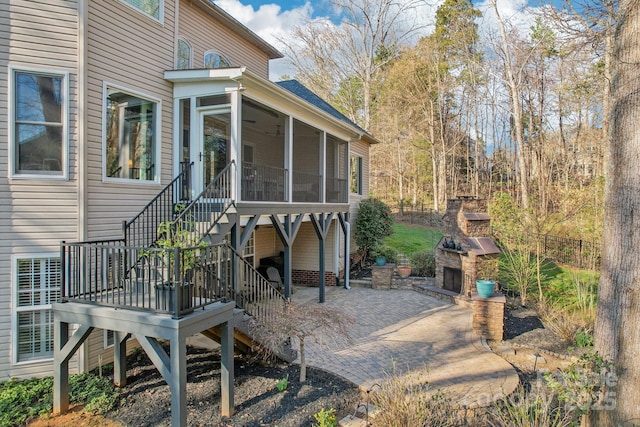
[122,162,193,247]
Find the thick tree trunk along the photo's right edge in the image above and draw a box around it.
[589,0,640,427]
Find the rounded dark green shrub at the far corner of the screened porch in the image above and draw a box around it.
[354,199,393,257]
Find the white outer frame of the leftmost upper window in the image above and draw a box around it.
[8,65,69,181]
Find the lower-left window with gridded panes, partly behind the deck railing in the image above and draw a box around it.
[13,254,62,363]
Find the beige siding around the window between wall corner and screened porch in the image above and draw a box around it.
[86,0,175,239]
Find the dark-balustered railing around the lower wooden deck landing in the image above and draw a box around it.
[61,240,233,318]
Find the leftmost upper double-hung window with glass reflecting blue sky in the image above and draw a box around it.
[9,69,69,178]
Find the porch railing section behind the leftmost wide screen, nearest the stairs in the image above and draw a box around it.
[241,162,288,202]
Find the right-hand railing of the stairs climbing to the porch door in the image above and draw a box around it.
[174,161,236,246]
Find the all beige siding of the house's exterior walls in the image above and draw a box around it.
[0,0,376,380]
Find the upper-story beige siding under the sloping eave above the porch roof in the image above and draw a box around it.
[178,0,269,79]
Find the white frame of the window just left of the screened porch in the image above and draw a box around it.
[102,82,162,185]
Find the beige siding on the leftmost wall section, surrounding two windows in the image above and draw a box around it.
[0,0,79,380]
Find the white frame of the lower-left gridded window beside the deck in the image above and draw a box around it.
[11,252,62,365]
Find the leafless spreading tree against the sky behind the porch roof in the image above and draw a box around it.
[280,0,425,129]
